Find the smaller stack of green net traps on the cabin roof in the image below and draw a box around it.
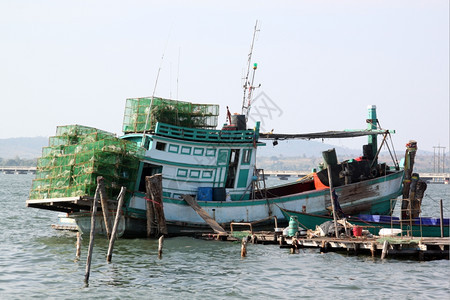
[123,97,219,133]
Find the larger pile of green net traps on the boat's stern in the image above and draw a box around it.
[30,125,144,199]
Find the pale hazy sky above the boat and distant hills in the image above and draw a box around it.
[0,0,450,151]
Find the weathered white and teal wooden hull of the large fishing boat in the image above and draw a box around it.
[72,171,403,236]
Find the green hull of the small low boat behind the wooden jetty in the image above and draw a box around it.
[282,210,449,237]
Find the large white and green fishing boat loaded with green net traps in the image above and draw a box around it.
[27,92,403,236]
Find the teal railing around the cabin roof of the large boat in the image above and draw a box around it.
[155,123,259,143]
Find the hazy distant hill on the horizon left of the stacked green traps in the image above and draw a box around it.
[0,137,48,159]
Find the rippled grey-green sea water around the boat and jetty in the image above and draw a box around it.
[0,174,450,299]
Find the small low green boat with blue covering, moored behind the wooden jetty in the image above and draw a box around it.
[281,208,449,237]
